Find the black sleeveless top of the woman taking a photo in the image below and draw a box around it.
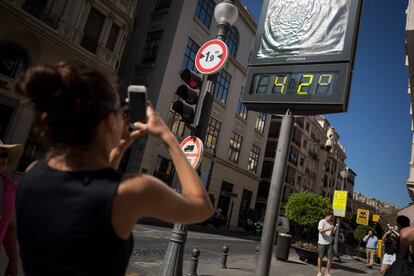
[16,162,133,276]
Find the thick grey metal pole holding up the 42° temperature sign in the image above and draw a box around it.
[256,110,293,276]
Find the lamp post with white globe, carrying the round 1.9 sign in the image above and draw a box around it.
[160,0,239,276]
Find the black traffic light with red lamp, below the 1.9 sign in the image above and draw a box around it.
[172,69,203,124]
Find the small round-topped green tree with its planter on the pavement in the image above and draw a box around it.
[286,191,331,264]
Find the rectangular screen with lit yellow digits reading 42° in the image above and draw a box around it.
[253,72,338,97]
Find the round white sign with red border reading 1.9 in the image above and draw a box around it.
[195,39,229,75]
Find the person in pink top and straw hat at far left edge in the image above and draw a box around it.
[0,140,23,276]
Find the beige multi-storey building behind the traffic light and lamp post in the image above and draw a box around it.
[120,0,270,226]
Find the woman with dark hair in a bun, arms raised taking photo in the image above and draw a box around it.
[16,63,213,276]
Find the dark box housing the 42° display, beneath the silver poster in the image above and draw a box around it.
[242,63,351,115]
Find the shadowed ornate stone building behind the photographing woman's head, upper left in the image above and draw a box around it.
[0,0,136,178]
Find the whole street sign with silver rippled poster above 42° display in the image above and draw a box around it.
[242,0,362,115]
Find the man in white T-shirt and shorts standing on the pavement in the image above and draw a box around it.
[317,212,338,276]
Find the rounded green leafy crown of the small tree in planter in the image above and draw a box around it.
[286,191,331,227]
